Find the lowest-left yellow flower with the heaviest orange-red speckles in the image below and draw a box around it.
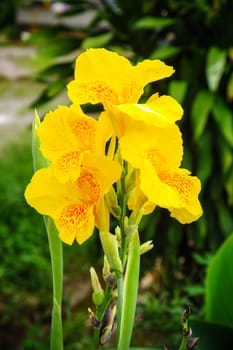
[25,152,121,244]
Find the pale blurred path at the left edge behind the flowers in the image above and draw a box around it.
[0,46,67,151]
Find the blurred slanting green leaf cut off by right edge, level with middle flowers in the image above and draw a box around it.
[213,96,233,147]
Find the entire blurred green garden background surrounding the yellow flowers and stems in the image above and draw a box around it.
[0,0,233,350]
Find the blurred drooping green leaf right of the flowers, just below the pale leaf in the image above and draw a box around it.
[191,90,213,140]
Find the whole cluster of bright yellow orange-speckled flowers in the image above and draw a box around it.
[25,49,202,244]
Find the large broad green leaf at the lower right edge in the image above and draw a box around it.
[205,234,233,327]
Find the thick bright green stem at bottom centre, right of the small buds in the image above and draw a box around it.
[117,230,140,350]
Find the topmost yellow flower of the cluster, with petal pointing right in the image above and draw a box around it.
[68,49,174,109]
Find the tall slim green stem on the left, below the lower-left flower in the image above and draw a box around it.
[45,218,63,350]
